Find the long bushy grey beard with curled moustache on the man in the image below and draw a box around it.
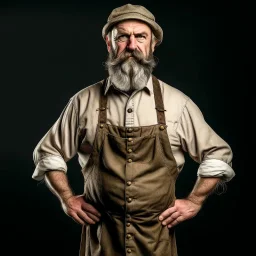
[105,50,156,92]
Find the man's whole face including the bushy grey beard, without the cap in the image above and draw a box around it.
[105,20,156,92]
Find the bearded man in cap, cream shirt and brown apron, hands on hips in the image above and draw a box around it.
[32,4,234,256]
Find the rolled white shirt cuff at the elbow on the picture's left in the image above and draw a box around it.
[32,156,67,181]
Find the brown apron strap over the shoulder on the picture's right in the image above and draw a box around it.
[152,76,166,125]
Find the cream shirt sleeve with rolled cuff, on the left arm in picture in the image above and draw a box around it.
[32,98,79,181]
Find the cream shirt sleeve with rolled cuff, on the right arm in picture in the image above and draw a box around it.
[177,99,235,181]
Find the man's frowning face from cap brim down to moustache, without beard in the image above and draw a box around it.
[108,20,154,58]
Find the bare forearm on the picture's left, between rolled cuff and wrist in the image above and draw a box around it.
[45,171,74,202]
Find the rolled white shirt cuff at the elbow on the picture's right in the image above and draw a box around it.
[197,159,235,182]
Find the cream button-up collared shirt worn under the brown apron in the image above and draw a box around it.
[32,77,235,182]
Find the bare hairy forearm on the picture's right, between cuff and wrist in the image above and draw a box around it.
[187,177,220,205]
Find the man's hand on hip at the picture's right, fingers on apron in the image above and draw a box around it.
[159,199,202,228]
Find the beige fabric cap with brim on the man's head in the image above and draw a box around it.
[102,4,163,45]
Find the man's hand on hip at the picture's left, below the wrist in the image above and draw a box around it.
[61,195,101,225]
